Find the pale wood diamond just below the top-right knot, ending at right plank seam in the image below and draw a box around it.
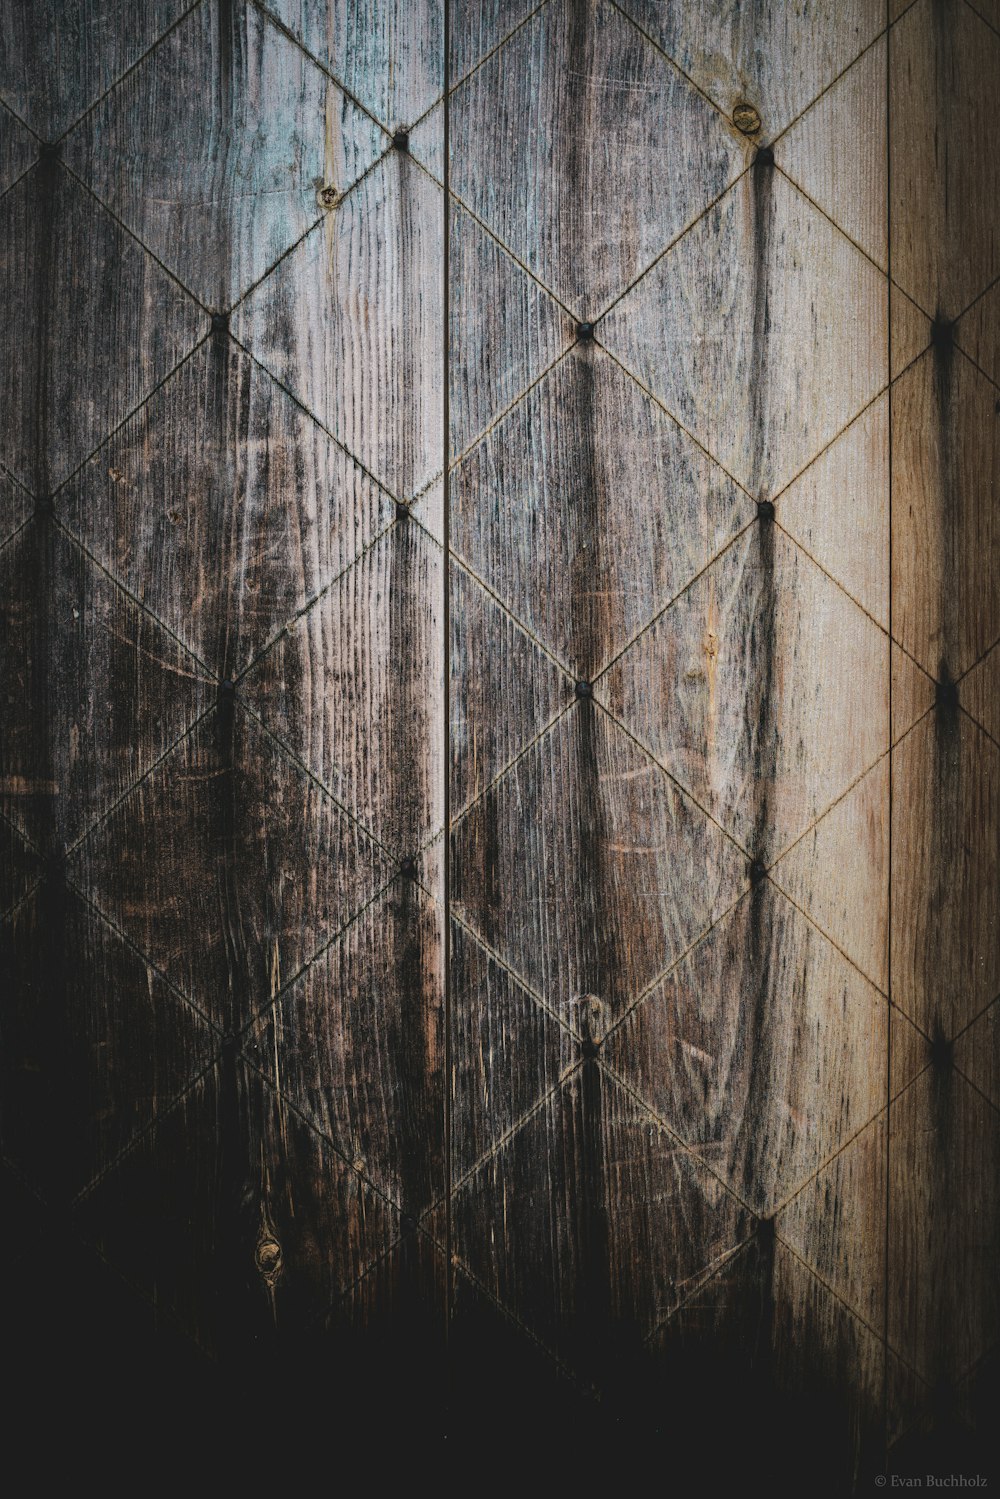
[600,156,888,499]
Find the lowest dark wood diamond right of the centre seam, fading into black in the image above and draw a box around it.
[453,1058,748,1382]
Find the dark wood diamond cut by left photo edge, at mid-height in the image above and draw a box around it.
[0,514,213,857]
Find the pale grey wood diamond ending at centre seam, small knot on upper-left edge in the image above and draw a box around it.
[232,150,444,501]
